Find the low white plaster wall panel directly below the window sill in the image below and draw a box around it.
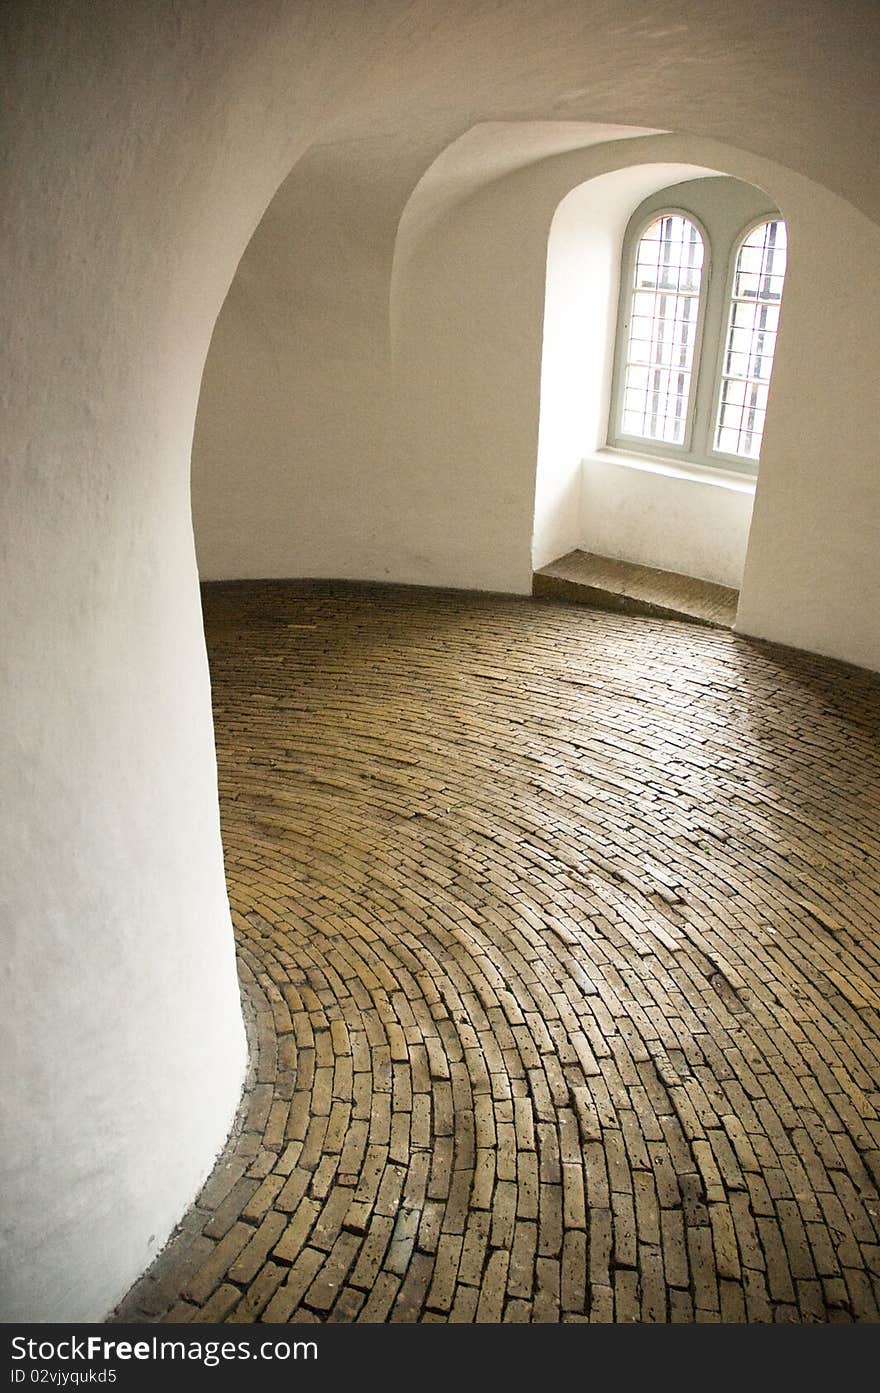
[578,454,755,589]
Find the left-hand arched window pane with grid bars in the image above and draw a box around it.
[621,213,704,444]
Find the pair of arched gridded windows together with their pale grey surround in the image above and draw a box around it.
[608,178,788,472]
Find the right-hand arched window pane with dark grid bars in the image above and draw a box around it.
[714,221,788,460]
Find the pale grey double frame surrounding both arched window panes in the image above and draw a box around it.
[606,189,791,479]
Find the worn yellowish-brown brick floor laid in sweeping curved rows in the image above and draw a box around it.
[118,584,880,1322]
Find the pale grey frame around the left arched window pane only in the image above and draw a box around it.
[608,203,712,460]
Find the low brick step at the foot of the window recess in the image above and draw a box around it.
[532,552,739,628]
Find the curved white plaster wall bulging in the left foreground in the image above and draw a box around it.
[0,0,403,1321]
